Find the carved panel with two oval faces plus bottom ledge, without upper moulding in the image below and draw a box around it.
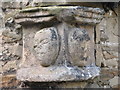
[17,23,100,82]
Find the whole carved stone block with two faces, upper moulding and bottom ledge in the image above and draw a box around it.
[15,6,104,82]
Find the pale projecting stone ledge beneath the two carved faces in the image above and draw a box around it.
[17,66,100,82]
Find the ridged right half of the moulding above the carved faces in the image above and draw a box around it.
[58,7,104,25]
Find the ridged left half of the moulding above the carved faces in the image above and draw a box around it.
[15,8,55,25]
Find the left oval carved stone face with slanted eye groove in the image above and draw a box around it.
[34,27,59,66]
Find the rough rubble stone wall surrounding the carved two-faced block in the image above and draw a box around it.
[0,2,120,88]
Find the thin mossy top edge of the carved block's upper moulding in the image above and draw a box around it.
[19,6,105,14]
